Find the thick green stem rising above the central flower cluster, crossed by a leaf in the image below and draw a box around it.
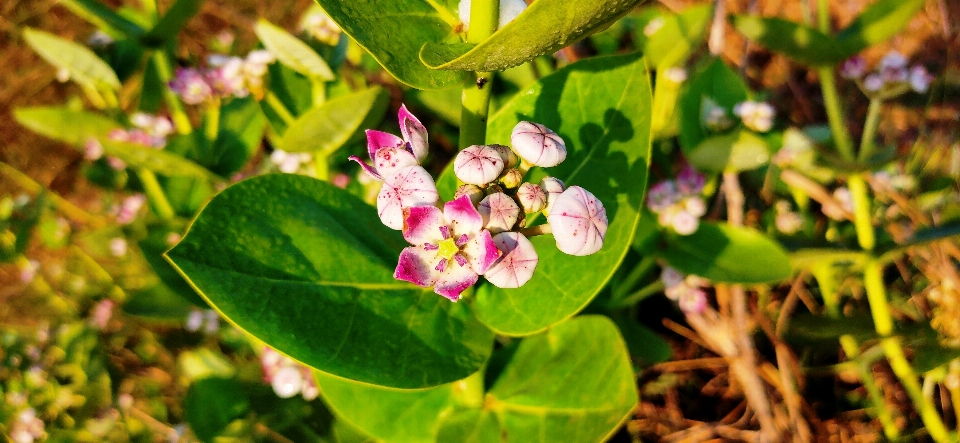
[460,0,500,149]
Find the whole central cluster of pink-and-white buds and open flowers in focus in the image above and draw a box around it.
[351,106,607,301]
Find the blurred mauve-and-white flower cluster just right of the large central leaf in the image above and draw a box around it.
[647,166,707,235]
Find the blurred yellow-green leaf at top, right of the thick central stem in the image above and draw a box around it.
[643,4,713,70]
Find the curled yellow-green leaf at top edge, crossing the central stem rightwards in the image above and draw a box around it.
[420,0,642,72]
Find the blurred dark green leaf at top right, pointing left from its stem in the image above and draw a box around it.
[731,15,847,67]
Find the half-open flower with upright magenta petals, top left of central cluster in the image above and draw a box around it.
[350,105,427,180]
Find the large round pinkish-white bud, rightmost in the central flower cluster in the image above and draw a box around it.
[547,186,607,255]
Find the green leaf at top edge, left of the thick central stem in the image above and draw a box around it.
[317,0,464,89]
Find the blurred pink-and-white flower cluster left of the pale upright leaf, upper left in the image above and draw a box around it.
[170,50,276,105]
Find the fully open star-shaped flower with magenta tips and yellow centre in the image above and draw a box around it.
[393,196,500,301]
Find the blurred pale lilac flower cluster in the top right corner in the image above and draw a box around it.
[840,51,933,97]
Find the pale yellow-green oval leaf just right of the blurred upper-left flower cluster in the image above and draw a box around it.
[253,19,335,82]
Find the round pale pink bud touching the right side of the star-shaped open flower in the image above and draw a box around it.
[483,232,540,288]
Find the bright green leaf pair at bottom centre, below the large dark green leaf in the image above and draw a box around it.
[318,316,638,443]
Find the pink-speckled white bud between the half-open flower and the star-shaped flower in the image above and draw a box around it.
[377,166,440,230]
